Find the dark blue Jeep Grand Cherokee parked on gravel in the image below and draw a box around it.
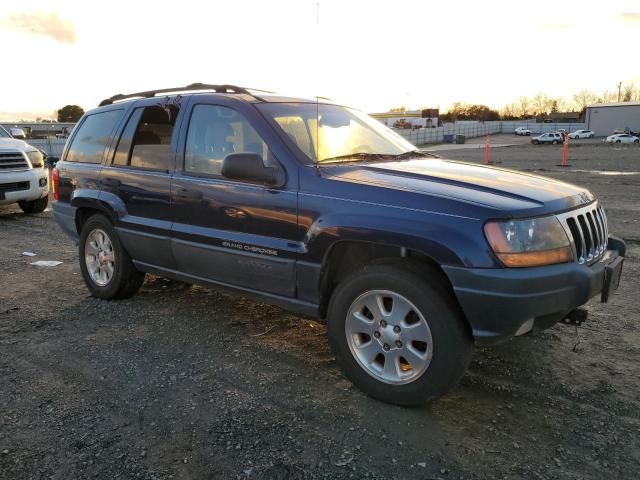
[53,84,625,405]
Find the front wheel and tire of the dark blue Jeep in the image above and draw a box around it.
[327,264,472,406]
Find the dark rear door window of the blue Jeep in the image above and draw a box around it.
[113,106,178,171]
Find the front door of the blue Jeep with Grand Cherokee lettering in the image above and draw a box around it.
[171,96,302,297]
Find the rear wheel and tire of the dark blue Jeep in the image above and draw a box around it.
[78,214,144,300]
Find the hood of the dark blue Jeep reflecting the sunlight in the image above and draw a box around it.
[323,159,593,211]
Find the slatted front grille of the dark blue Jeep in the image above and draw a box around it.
[558,204,609,264]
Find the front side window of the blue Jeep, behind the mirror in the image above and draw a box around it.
[184,105,274,175]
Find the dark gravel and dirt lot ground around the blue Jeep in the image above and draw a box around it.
[0,141,640,480]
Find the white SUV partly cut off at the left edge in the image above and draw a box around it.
[0,126,49,213]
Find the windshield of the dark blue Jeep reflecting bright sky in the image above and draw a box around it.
[258,103,416,163]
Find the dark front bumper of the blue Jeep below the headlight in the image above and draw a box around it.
[442,237,625,344]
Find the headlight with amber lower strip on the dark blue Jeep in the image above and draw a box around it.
[484,217,573,267]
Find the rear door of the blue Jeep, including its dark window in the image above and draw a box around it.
[100,99,180,268]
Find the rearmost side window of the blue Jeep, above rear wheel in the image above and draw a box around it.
[65,110,123,163]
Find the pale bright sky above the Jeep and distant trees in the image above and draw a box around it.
[0,0,640,121]
